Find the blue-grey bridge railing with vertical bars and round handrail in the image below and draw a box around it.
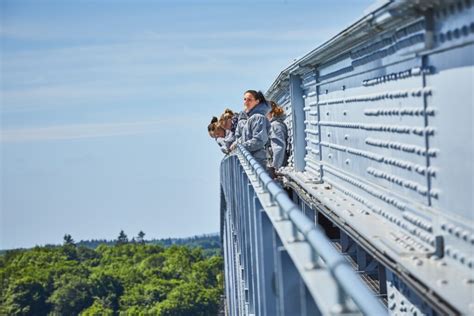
[221,146,387,315]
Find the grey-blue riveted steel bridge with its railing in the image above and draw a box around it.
[221,0,474,315]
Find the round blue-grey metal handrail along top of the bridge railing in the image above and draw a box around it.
[237,145,387,316]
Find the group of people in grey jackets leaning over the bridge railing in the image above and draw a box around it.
[208,90,288,178]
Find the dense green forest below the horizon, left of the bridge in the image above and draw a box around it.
[0,231,223,315]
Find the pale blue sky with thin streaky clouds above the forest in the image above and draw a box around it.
[0,0,373,249]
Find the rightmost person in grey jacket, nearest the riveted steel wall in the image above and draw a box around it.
[267,101,288,178]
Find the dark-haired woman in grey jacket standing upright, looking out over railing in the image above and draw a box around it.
[231,90,270,168]
